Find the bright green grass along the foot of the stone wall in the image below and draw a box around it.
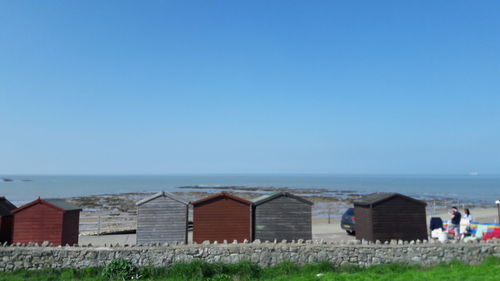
[0,257,500,281]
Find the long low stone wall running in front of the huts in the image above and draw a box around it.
[0,240,500,271]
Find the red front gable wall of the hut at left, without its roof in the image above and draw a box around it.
[12,204,63,245]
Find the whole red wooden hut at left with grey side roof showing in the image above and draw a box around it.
[12,198,81,245]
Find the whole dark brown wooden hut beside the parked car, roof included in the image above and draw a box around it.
[354,192,427,242]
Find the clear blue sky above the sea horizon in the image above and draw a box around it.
[0,0,500,174]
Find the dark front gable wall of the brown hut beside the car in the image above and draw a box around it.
[372,197,427,241]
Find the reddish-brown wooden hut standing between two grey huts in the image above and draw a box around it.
[192,192,252,243]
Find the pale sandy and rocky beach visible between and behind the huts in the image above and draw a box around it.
[75,187,498,245]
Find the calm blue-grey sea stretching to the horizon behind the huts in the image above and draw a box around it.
[0,174,500,206]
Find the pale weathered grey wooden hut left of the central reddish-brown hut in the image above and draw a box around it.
[136,192,189,244]
